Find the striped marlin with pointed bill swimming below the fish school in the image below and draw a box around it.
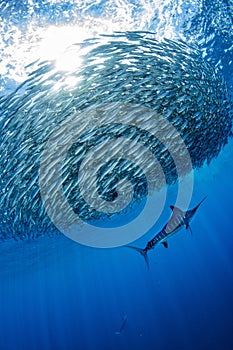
[126,196,207,269]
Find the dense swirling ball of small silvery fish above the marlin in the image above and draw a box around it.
[0,33,232,239]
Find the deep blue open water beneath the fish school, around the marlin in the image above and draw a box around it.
[0,1,233,350]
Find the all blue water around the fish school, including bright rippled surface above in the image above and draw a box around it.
[0,0,233,350]
